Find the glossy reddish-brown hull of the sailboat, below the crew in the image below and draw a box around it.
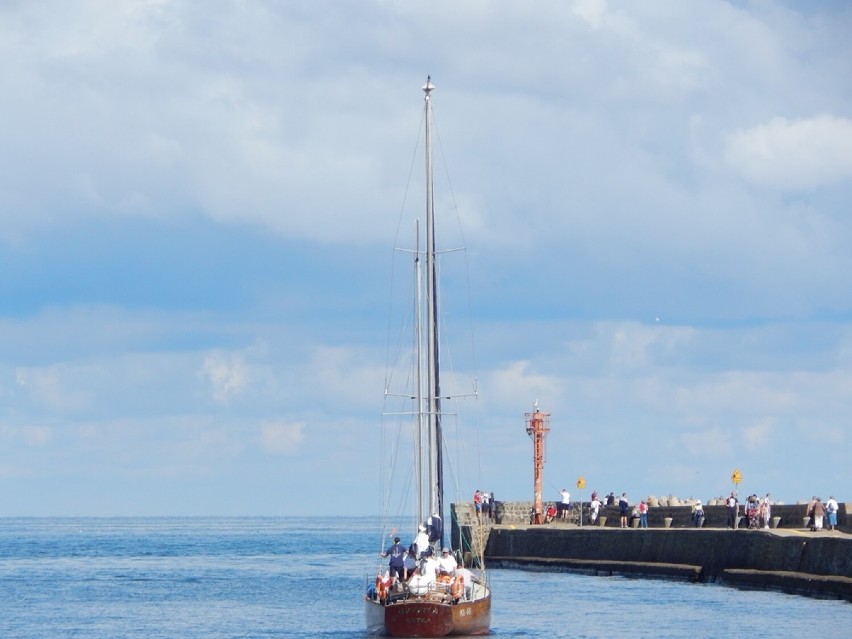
[364,593,491,637]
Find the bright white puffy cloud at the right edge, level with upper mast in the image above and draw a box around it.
[724,115,852,191]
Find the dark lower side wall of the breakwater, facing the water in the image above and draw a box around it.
[484,525,852,602]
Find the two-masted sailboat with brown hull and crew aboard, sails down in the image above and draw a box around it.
[364,77,491,637]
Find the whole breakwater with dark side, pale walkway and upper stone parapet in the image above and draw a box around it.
[452,502,852,602]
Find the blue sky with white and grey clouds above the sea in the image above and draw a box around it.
[0,0,852,516]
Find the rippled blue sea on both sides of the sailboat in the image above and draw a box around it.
[0,517,852,639]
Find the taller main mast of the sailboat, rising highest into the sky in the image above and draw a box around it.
[423,76,444,544]
